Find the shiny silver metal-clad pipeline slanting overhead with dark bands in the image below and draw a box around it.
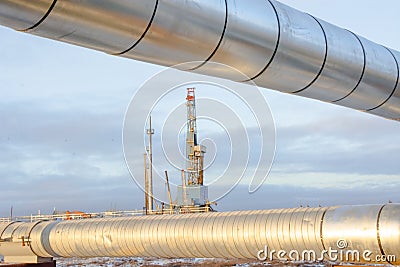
[0,0,400,120]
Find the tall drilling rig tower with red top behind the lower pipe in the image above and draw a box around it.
[177,88,208,207]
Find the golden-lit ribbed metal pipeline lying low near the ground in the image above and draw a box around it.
[0,204,400,264]
